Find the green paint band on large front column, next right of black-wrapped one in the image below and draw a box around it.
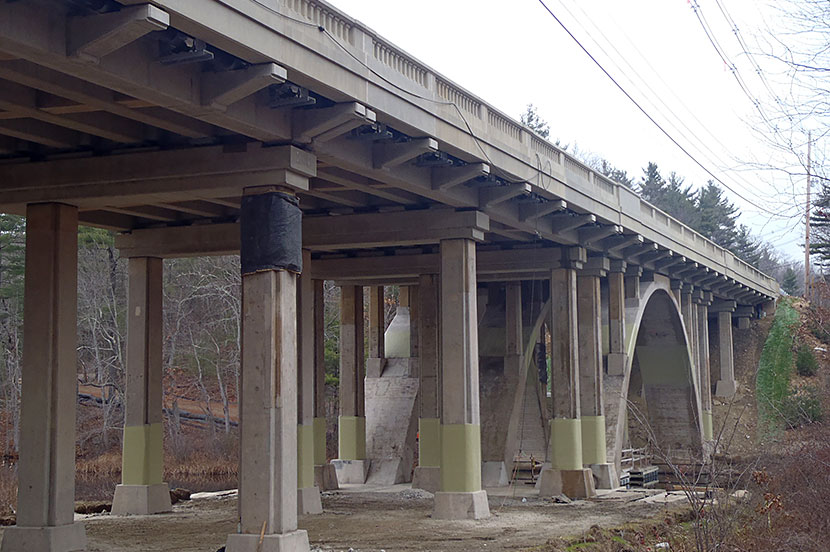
[441,424,481,493]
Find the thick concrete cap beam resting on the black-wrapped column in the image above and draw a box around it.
[0,143,317,208]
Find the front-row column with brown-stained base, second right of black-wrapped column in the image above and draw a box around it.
[539,248,594,497]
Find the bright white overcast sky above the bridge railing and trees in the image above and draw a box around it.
[329,0,805,266]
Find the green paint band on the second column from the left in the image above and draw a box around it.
[121,423,164,485]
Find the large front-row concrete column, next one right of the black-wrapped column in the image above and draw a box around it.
[433,239,490,519]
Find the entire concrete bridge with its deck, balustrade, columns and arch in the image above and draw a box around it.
[0,0,778,552]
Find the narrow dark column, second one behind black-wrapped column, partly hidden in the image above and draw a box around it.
[306,280,340,491]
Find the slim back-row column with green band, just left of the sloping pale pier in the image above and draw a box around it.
[332,286,369,484]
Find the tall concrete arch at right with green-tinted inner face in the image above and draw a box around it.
[604,276,703,470]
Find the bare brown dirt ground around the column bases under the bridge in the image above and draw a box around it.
[0,485,685,552]
